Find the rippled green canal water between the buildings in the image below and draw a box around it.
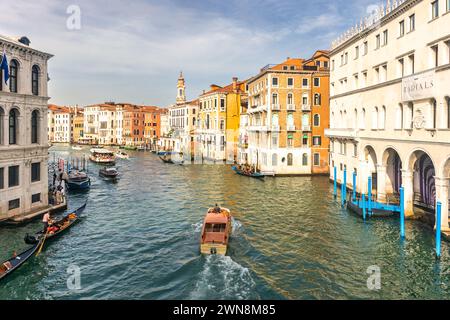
[0,146,450,299]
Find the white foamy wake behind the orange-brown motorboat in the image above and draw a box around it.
[190,255,259,300]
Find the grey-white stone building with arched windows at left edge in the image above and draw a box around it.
[0,36,52,220]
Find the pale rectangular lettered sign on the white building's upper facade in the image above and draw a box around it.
[402,70,436,101]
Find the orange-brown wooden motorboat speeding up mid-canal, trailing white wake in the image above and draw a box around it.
[200,208,232,255]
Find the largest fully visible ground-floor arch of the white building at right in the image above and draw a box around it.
[409,150,436,220]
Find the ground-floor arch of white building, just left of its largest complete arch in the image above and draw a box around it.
[383,148,402,203]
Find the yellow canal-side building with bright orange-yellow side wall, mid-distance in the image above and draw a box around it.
[197,78,246,162]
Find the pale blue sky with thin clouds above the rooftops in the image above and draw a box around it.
[0,0,381,107]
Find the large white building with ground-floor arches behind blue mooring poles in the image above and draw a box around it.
[327,0,450,230]
